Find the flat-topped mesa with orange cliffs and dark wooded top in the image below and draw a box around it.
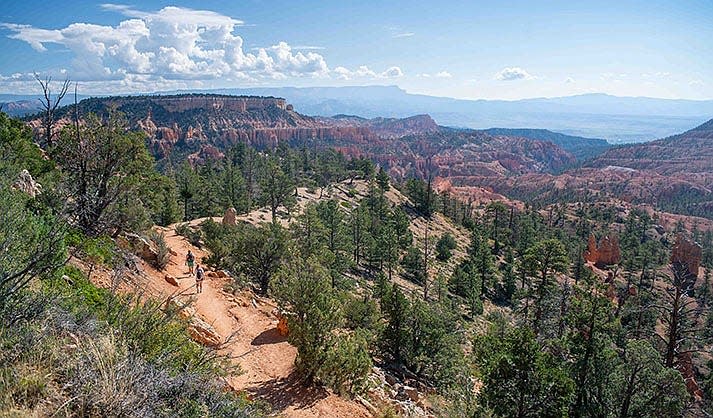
[35,95,384,160]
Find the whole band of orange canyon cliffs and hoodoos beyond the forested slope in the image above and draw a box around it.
[28,94,713,218]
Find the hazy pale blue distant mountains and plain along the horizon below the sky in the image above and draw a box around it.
[0,86,713,143]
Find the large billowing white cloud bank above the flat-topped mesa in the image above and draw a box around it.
[2,4,330,83]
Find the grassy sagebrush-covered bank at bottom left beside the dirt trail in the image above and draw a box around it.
[0,267,262,417]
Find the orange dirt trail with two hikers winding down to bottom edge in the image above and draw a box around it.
[142,224,371,417]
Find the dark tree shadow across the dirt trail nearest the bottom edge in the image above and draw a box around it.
[247,372,329,411]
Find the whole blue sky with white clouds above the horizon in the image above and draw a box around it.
[0,0,713,99]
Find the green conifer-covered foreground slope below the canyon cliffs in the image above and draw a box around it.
[0,101,713,417]
